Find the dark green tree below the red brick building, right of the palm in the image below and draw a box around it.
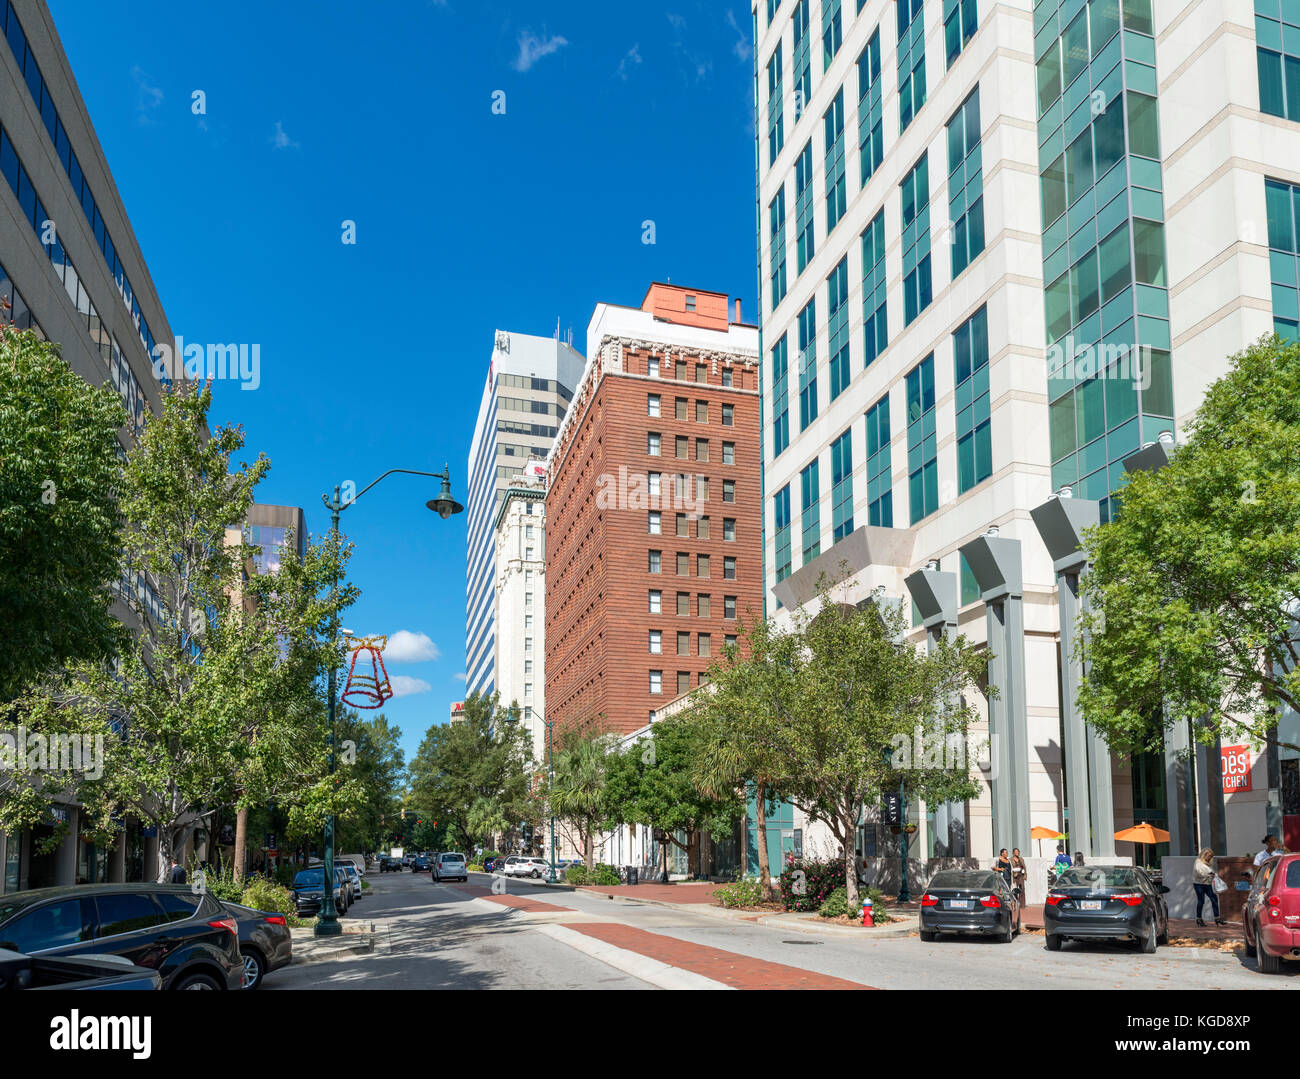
[605,715,744,879]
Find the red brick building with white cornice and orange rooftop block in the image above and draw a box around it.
[546,283,763,733]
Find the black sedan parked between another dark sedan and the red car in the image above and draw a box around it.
[1043,866,1169,954]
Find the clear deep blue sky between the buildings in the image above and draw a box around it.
[48,0,758,758]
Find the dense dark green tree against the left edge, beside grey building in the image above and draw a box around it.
[0,327,126,705]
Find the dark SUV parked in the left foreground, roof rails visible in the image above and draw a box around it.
[0,884,243,989]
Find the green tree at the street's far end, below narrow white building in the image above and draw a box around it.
[407,693,536,853]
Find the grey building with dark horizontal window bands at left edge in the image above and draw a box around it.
[0,0,182,893]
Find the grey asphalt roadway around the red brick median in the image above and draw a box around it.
[265,872,1300,991]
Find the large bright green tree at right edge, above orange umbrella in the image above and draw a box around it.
[1080,338,1300,753]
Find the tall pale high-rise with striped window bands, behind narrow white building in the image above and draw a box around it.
[465,330,584,694]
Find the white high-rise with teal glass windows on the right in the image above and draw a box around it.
[753,0,1300,878]
